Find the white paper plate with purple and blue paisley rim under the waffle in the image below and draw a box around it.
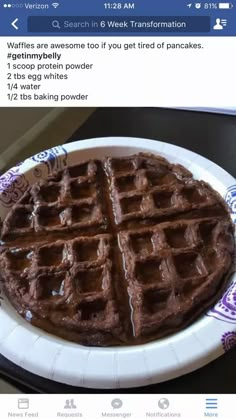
[0,137,236,389]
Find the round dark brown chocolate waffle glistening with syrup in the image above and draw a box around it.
[0,154,234,346]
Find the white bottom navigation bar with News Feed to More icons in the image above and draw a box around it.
[0,394,235,419]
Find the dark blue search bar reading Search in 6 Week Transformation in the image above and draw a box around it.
[28,16,210,35]
